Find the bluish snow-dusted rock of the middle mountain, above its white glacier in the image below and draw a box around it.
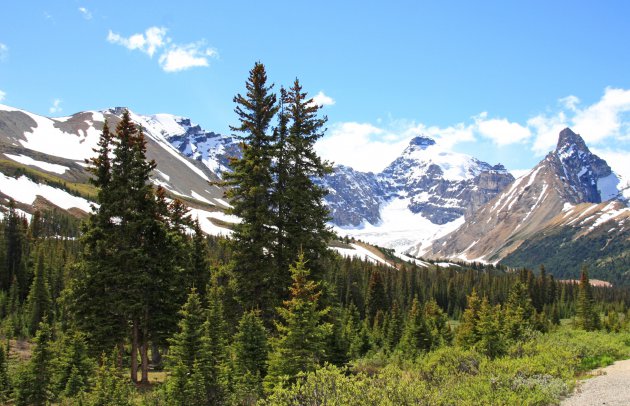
[322,136,514,227]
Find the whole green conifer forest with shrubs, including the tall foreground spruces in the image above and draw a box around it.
[0,64,630,405]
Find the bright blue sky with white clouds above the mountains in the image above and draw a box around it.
[0,0,630,179]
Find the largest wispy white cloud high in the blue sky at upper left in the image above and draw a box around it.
[107,27,218,72]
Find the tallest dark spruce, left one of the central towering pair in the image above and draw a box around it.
[224,63,278,318]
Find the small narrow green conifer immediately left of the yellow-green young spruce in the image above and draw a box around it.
[233,310,269,405]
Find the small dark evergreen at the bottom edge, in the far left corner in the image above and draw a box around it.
[15,322,53,406]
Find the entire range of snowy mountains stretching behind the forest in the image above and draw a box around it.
[0,105,630,283]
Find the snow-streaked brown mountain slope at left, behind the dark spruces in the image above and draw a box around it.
[0,105,236,234]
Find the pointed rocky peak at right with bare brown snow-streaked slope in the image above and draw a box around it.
[424,128,620,262]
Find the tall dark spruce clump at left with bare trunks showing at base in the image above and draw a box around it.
[71,110,183,383]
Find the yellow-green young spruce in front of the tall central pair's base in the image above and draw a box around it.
[264,254,332,391]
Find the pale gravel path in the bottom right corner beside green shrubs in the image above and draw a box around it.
[561,360,630,406]
